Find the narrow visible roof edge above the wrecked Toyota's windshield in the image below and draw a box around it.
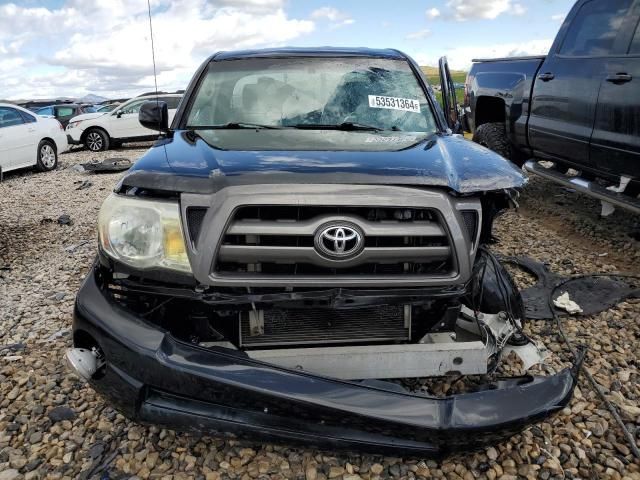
[210,47,407,61]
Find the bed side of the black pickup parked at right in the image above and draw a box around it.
[465,56,546,154]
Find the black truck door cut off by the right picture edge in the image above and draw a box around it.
[591,0,640,180]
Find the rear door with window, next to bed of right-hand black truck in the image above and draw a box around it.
[529,0,633,168]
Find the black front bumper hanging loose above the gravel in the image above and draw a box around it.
[74,266,582,456]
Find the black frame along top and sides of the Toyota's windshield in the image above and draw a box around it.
[170,49,449,133]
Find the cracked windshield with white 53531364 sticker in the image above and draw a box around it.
[187,58,436,133]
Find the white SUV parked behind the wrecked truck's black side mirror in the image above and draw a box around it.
[66,93,182,152]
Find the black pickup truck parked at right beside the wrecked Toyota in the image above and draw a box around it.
[462,0,640,213]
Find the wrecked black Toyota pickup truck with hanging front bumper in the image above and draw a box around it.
[67,48,578,455]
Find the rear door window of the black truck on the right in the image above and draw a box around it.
[560,0,632,57]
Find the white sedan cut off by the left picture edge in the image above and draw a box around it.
[0,103,69,174]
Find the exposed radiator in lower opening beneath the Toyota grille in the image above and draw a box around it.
[240,305,411,348]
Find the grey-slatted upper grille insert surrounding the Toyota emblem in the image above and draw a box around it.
[214,205,454,277]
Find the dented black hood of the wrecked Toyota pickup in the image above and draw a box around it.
[123,129,526,194]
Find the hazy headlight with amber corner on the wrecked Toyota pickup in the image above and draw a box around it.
[98,194,191,273]
